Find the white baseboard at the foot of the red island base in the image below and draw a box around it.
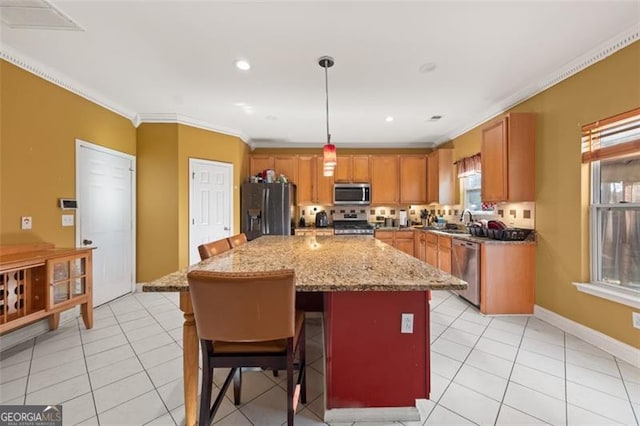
[324,407,420,423]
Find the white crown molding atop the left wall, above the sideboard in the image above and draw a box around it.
[0,46,135,121]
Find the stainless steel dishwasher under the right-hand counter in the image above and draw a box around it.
[451,238,480,306]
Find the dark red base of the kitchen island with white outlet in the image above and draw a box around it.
[324,291,430,421]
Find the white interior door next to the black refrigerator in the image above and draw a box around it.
[189,158,233,265]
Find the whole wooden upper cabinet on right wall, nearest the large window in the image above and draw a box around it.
[481,113,535,202]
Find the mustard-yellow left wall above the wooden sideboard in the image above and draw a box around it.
[0,60,136,247]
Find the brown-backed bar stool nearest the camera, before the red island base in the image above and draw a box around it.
[187,269,307,426]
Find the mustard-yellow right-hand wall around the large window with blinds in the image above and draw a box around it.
[453,42,640,348]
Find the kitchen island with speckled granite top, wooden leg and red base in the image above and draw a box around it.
[143,236,466,425]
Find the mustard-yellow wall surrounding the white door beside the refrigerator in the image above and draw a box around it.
[137,124,249,282]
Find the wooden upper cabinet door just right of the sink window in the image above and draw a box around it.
[481,117,508,202]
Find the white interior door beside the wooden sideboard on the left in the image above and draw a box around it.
[76,140,135,306]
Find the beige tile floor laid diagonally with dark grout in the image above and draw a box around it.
[0,292,640,426]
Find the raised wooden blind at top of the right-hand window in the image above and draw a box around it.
[582,108,640,163]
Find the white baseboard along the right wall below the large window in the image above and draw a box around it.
[533,305,640,368]
